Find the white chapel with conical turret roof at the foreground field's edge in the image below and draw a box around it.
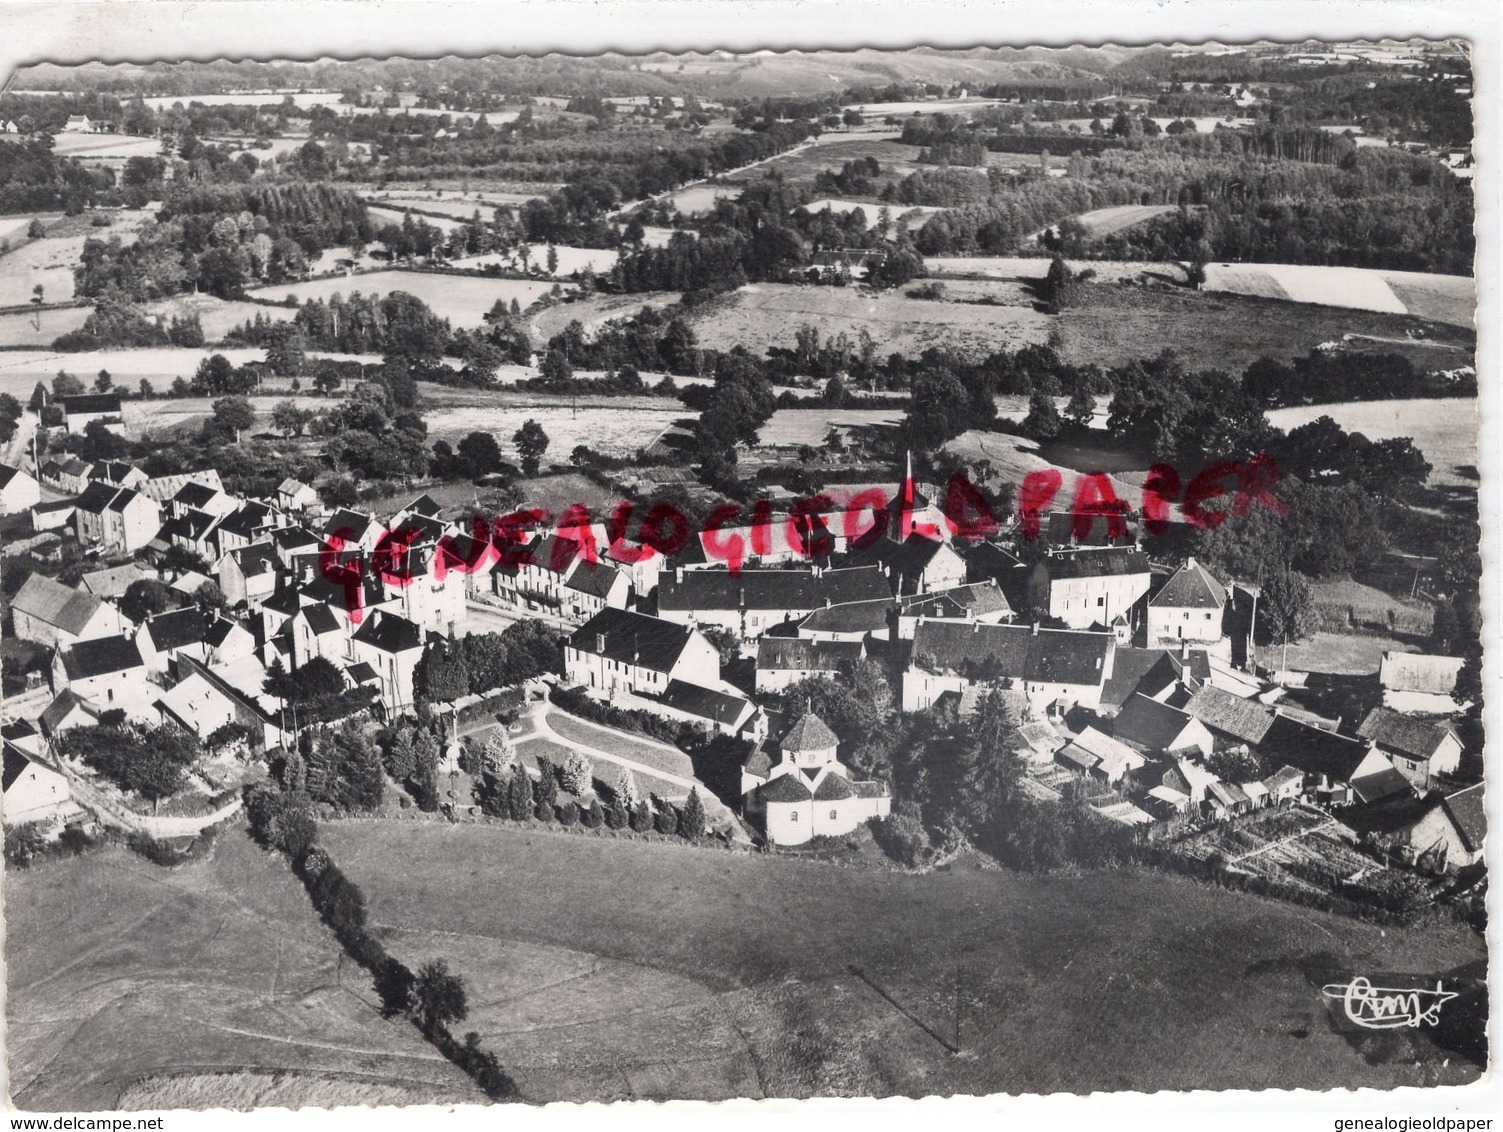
[741,711,891,845]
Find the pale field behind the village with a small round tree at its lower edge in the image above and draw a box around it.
[422,383,690,454]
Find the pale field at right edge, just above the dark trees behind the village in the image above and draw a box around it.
[1269,397,1480,487]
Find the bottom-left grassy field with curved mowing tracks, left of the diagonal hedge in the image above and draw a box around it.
[5,830,479,1111]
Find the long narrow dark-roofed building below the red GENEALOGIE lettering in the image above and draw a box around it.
[658,565,893,640]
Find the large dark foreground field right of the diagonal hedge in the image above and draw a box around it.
[323,822,1485,1100]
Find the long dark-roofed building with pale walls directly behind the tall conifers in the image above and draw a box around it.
[902,621,1115,711]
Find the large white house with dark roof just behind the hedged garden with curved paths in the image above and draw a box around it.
[564,609,720,698]
